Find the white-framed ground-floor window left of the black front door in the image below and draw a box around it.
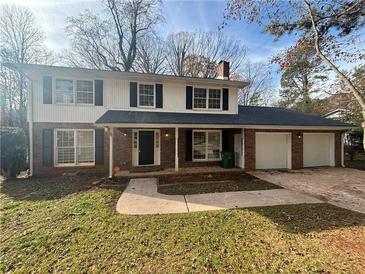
[55,129,95,165]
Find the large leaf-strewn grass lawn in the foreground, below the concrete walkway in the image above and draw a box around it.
[0,178,365,273]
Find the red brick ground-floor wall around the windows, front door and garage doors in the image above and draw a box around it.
[33,123,342,176]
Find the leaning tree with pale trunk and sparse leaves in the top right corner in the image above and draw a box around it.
[223,0,365,150]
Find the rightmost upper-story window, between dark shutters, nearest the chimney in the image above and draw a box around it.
[194,88,222,109]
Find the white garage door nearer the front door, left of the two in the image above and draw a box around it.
[256,133,291,169]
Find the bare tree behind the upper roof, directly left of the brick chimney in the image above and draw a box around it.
[166,31,246,78]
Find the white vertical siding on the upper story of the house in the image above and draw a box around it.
[32,71,238,123]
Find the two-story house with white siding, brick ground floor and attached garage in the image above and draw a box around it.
[7,61,350,176]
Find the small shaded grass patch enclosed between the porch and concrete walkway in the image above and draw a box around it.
[157,174,282,195]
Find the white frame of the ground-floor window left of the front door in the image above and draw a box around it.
[53,128,95,167]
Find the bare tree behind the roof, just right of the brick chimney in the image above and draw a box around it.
[232,61,273,106]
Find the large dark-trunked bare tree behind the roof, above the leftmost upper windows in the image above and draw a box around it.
[66,0,163,71]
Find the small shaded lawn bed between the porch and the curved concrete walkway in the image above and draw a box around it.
[157,173,282,195]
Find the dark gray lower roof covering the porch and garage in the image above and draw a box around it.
[96,106,352,127]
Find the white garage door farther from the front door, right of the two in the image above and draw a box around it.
[303,133,335,167]
